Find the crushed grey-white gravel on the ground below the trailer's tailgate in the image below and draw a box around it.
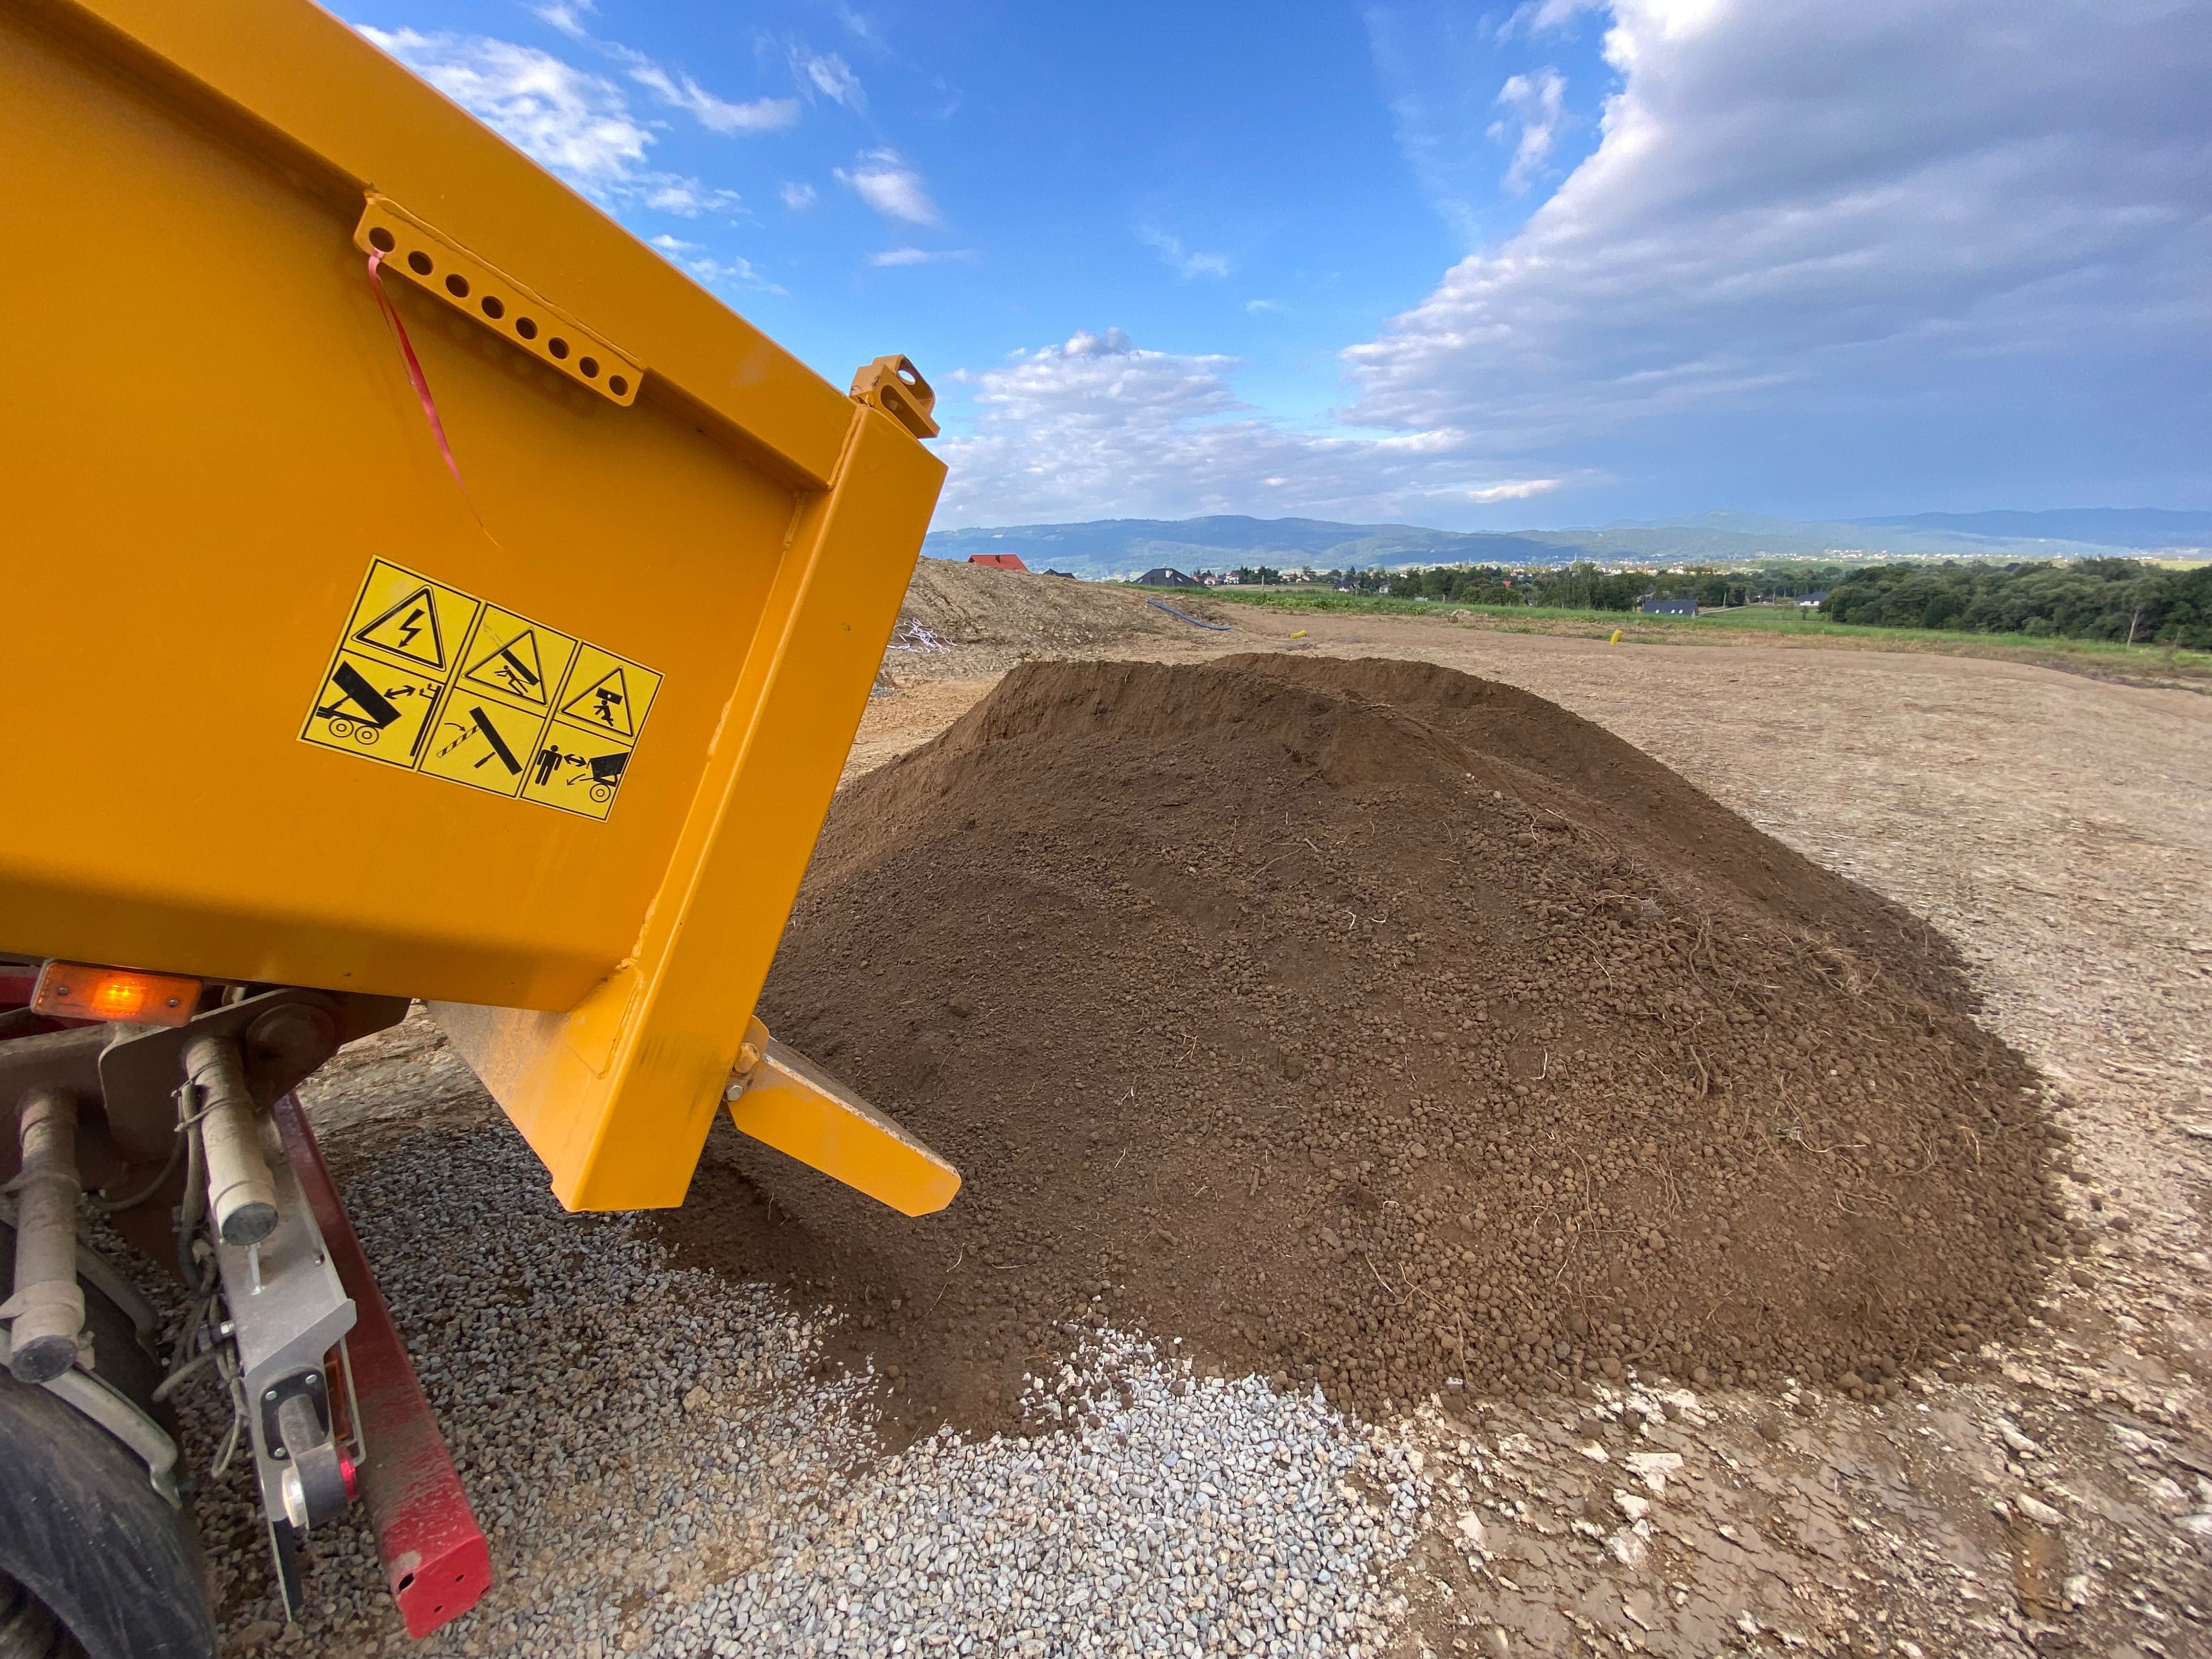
[193,1119,1429,1659]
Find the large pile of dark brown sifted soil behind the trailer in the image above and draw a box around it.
[666,657,2064,1425]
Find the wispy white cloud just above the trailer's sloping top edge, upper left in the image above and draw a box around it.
[360,29,739,217]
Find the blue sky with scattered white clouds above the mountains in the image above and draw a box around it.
[345,0,2212,529]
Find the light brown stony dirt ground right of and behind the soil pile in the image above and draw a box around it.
[854,571,2212,1659]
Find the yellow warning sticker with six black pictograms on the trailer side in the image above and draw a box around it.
[301,560,662,819]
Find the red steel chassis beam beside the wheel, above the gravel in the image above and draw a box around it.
[274,1095,491,1637]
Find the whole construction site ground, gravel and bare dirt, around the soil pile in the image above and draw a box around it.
[211,566,2212,1659]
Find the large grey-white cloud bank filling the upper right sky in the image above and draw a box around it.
[1345,0,2212,467]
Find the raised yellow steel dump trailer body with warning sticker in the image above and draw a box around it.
[0,0,943,1207]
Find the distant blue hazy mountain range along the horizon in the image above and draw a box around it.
[922,506,2212,577]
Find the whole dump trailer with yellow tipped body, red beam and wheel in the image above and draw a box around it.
[0,0,958,1659]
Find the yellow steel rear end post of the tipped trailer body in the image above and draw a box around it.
[433,407,945,1210]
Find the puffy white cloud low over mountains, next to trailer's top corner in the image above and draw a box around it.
[938,328,1553,527]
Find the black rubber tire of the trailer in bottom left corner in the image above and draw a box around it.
[0,1223,217,1659]
